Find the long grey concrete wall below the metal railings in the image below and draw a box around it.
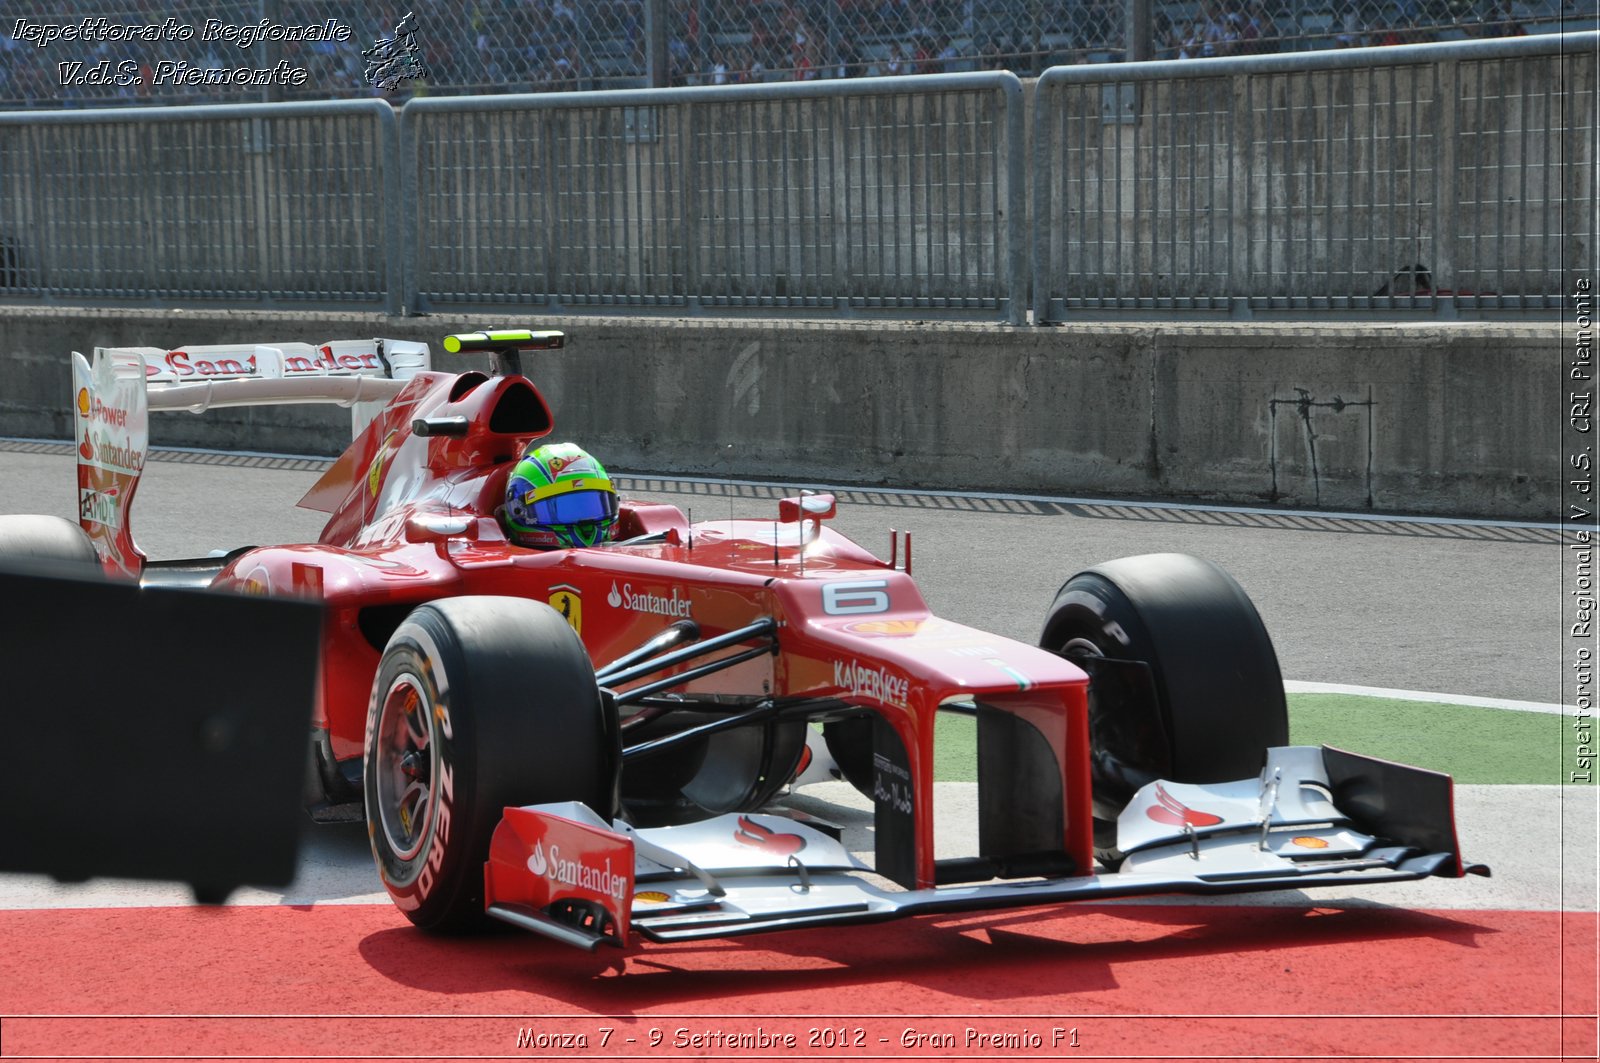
[0,307,1565,519]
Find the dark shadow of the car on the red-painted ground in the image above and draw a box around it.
[360,905,1499,1017]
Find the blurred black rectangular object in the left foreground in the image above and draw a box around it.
[0,557,322,903]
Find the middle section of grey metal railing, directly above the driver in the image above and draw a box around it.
[402,72,1027,323]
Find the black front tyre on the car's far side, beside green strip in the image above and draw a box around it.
[1038,554,1290,868]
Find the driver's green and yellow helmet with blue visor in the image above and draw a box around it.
[506,443,616,549]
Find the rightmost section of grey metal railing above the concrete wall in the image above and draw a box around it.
[1032,34,1600,322]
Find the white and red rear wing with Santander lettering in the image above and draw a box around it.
[72,339,429,578]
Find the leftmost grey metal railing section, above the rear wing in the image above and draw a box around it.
[0,99,402,314]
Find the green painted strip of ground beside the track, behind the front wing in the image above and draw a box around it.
[934,693,1571,786]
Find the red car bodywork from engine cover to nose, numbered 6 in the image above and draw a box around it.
[214,373,1093,889]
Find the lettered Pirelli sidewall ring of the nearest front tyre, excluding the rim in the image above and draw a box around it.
[362,608,473,927]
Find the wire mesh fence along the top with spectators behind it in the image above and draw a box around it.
[0,0,1595,107]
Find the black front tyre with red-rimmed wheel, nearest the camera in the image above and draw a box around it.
[363,597,619,932]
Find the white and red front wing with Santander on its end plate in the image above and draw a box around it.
[486,746,1488,948]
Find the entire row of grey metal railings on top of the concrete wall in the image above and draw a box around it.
[0,34,1600,323]
